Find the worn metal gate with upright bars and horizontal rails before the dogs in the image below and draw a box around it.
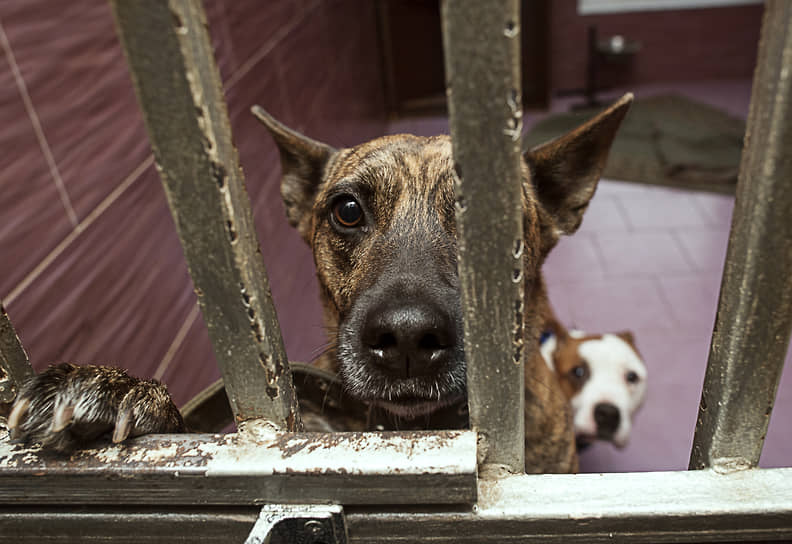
[0,0,792,543]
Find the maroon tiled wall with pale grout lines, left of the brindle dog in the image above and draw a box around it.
[0,0,384,403]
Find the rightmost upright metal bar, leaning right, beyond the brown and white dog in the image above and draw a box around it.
[690,0,792,469]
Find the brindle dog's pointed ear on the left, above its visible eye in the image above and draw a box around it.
[251,106,336,241]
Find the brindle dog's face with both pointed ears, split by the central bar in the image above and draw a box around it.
[254,96,631,418]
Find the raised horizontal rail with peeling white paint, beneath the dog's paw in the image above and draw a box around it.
[0,430,476,508]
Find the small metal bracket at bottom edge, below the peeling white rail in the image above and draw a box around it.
[245,504,347,544]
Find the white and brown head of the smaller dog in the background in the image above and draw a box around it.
[540,322,647,448]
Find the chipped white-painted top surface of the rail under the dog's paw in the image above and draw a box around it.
[0,427,476,477]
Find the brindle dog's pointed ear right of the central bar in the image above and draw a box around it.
[523,93,633,239]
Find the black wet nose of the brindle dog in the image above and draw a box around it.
[361,301,457,378]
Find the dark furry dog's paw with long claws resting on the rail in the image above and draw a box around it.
[8,364,184,453]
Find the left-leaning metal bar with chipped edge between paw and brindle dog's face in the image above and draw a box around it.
[112,0,299,429]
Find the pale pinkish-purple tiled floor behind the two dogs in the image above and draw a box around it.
[390,81,792,472]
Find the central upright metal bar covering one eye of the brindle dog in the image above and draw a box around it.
[442,0,525,472]
